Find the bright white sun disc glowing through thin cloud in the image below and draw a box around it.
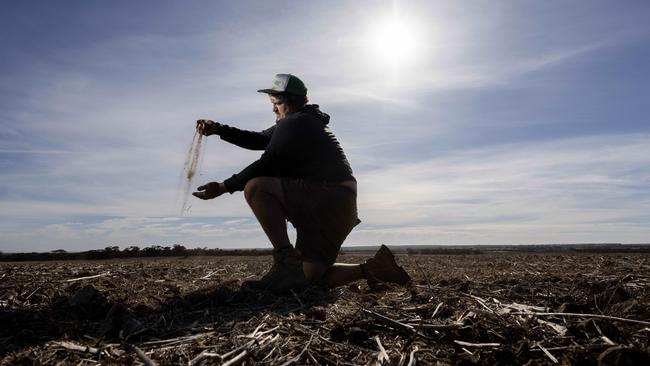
[367,15,419,68]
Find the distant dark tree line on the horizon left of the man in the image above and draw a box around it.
[0,244,271,261]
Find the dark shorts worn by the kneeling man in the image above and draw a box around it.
[282,178,361,264]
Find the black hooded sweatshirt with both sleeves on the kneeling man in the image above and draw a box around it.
[217,104,355,193]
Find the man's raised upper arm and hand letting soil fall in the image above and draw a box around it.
[196,119,275,150]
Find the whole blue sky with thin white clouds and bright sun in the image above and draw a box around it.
[0,0,650,252]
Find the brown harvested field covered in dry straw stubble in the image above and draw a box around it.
[0,252,650,365]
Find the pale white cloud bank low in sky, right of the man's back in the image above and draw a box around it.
[352,135,650,243]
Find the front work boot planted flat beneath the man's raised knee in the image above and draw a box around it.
[242,246,308,292]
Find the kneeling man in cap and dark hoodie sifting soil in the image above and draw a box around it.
[193,74,410,291]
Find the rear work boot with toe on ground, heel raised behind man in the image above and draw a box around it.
[361,245,411,288]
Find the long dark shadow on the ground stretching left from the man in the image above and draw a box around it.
[0,282,337,361]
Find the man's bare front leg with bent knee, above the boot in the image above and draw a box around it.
[244,177,291,249]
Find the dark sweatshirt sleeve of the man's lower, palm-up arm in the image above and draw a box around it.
[224,121,296,193]
